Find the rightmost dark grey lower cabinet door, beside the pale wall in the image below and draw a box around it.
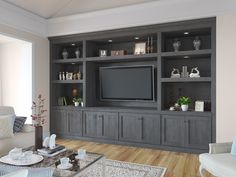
[186,117,211,149]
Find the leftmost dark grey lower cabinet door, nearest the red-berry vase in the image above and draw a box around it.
[53,110,68,135]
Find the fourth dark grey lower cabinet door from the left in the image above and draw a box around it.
[100,112,118,140]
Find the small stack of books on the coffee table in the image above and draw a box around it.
[38,144,66,157]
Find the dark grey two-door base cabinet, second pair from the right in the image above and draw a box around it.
[119,113,160,144]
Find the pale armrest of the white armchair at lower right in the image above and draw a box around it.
[209,142,232,154]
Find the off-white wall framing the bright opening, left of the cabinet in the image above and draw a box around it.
[0,24,49,136]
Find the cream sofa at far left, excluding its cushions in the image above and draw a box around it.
[0,106,34,157]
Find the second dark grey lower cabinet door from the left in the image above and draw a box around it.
[67,111,82,136]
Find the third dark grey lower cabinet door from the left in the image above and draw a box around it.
[84,111,102,137]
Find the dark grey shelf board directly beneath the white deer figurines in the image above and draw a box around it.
[161,77,211,82]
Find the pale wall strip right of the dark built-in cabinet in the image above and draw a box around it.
[216,13,236,142]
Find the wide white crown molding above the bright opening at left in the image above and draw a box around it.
[0,1,47,37]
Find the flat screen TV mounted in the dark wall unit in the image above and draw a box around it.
[99,65,155,101]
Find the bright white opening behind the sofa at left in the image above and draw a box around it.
[0,40,32,123]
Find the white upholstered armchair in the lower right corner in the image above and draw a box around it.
[199,143,236,177]
